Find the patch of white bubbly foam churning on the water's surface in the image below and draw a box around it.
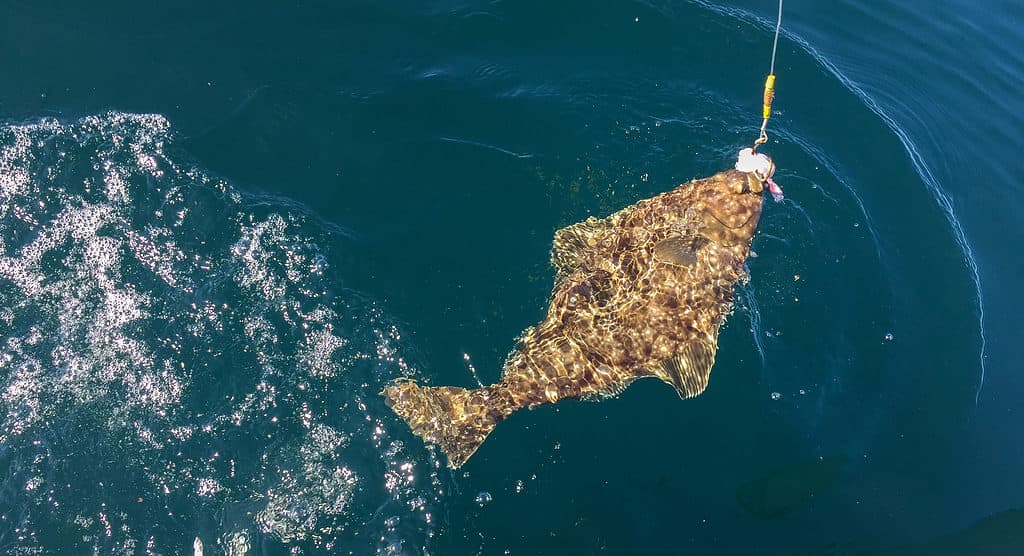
[0,114,440,554]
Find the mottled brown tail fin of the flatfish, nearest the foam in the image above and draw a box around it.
[381,379,513,469]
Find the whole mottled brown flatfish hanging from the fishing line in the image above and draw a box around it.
[382,170,763,468]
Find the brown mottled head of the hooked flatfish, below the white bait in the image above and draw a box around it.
[694,170,764,246]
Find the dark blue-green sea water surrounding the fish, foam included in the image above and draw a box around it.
[0,0,1024,555]
